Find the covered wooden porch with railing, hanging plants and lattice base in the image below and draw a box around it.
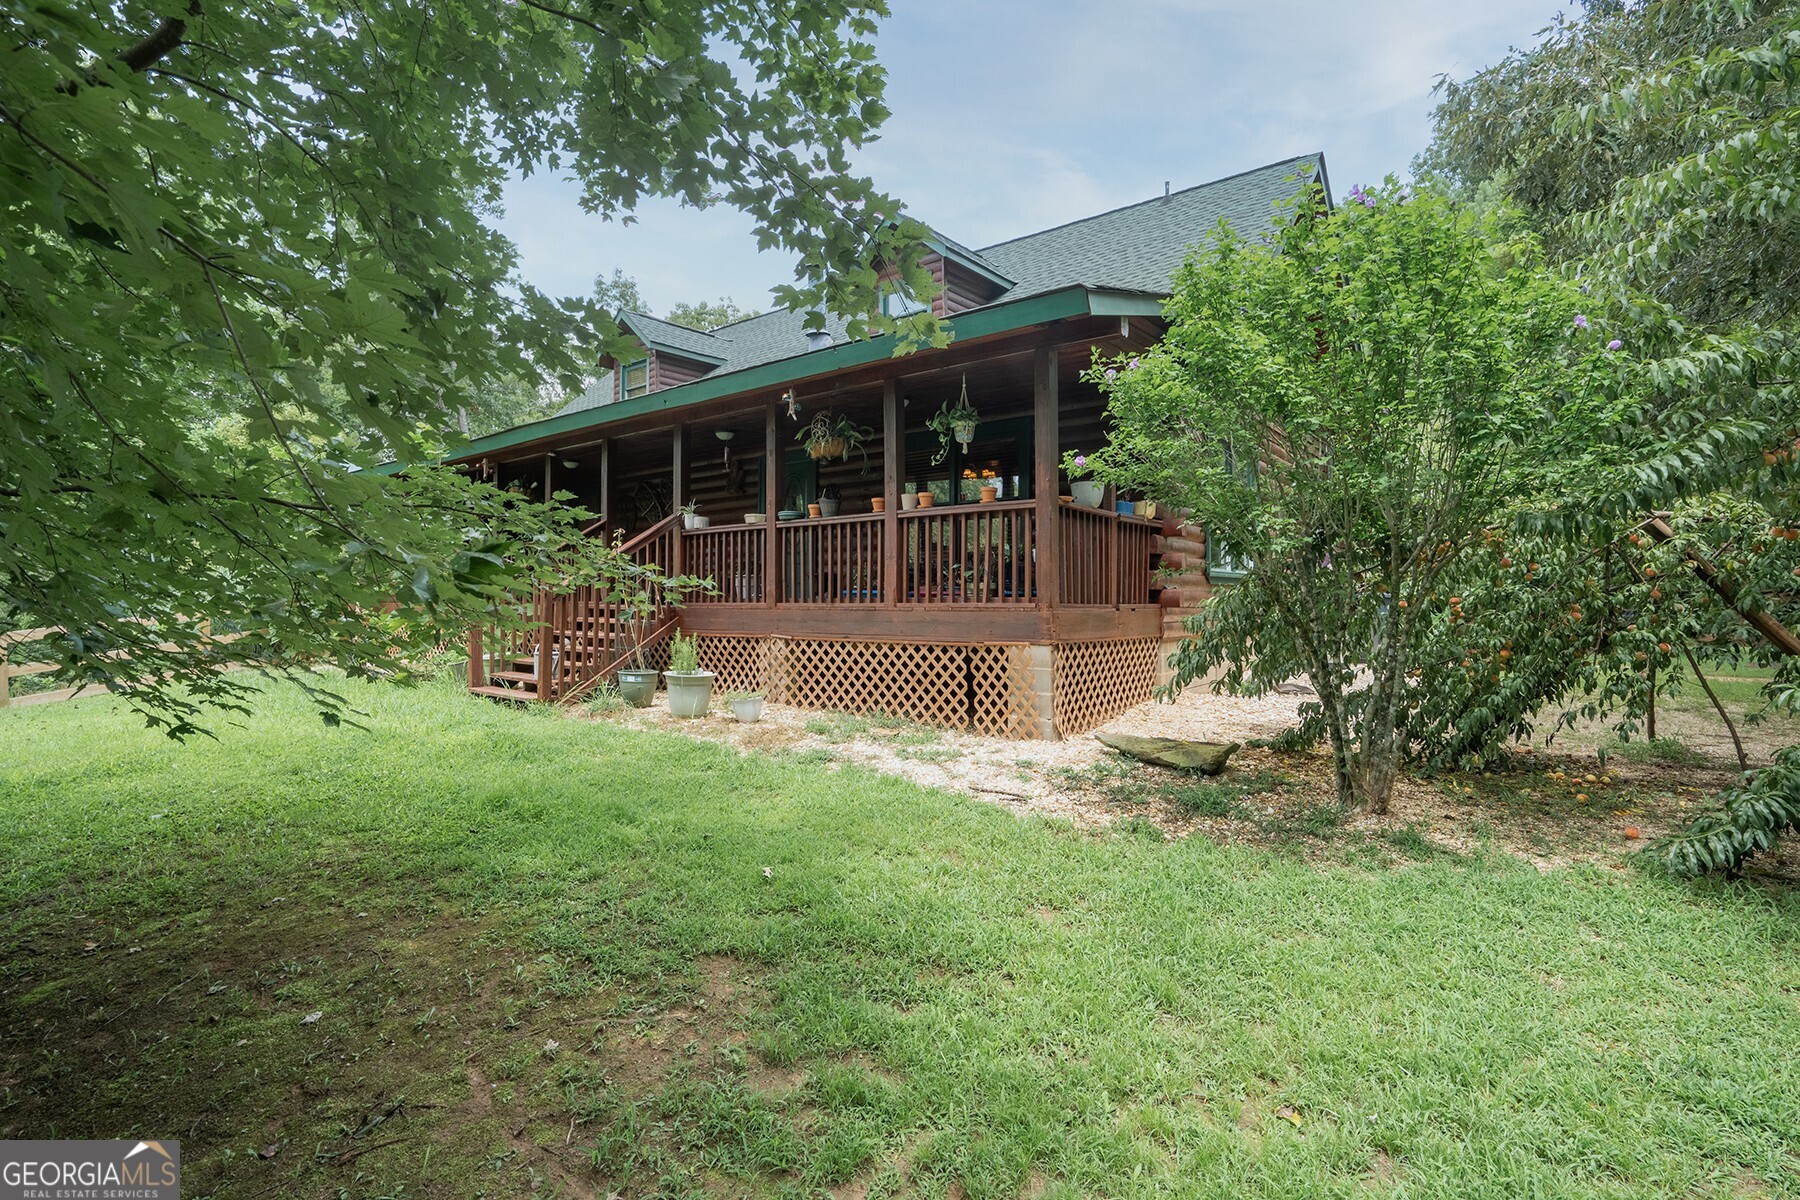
[472,320,1172,736]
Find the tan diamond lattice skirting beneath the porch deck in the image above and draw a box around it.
[698,635,1157,738]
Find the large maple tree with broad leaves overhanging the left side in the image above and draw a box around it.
[0,0,940,727]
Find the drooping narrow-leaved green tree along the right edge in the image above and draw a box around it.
[1424,2,1800,873]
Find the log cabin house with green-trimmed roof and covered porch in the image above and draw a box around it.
[459,155,1325,738]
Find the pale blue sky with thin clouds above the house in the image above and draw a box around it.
[499,0,1568,311]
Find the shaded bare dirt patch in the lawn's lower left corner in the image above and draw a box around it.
[0,883,806,1196]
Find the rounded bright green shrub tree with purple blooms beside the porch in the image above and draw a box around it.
[1071,182,1618,811]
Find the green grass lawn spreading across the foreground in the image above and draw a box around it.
[0,687,1800,1200]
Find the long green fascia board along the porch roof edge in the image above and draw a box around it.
[383,284,1163,475]
